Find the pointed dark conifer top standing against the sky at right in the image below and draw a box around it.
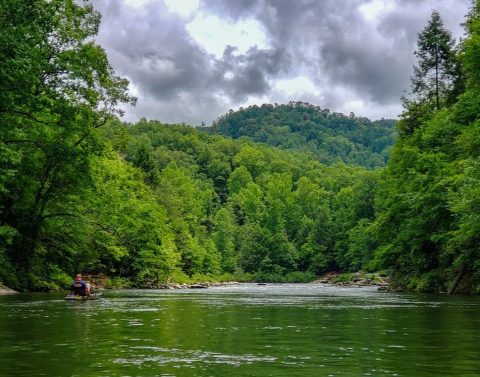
[411,10,459,110]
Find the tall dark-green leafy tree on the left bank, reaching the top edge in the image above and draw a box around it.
[0,0,134,286]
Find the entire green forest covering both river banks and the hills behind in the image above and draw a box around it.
[0,0,480,292]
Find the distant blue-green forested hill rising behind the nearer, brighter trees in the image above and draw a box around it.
[207,102,396,168]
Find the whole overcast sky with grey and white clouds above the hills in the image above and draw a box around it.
[92,0,470,126]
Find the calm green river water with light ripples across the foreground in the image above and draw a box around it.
[0,284,480,377]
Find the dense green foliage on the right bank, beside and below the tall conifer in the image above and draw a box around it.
[375,1,480,292]
